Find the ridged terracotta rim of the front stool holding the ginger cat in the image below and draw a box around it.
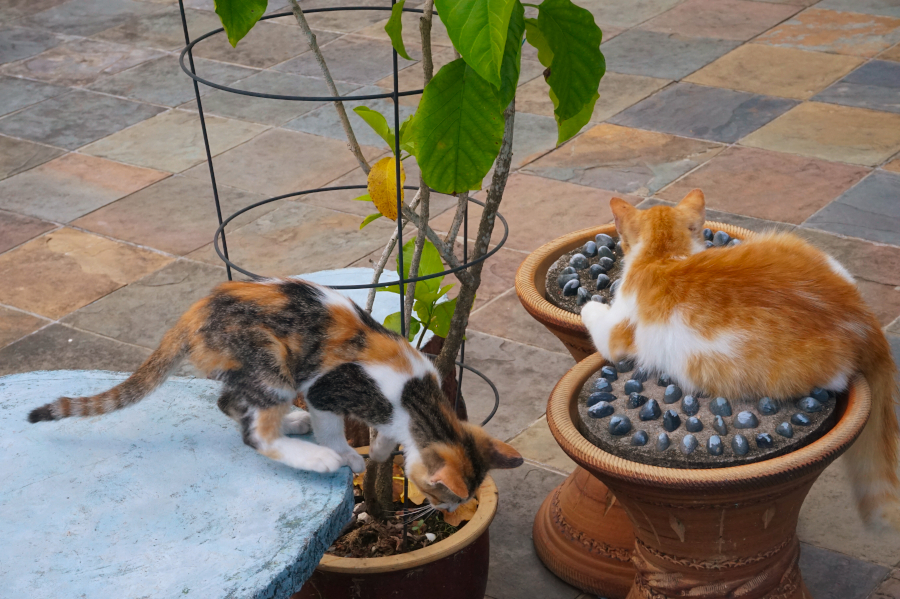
[547,354,871,490]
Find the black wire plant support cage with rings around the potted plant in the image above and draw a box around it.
[178,0,509,545]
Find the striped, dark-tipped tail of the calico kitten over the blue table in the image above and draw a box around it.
[28,310,195,422]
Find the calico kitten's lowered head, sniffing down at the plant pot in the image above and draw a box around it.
[407,423,524,512]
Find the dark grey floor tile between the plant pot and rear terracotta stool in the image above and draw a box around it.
[487,464,581,599]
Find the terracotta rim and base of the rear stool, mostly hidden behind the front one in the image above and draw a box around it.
[516,222,752,599]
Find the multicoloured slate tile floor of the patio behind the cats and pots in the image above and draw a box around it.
[0,0,900,599]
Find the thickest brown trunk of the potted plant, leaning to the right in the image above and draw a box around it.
[435,98,516,376]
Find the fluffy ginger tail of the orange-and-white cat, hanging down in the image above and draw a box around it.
[847,318,900,531]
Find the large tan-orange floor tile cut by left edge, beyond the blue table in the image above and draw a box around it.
[0,229,172,318]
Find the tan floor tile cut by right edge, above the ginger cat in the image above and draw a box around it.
[740,102,900,166]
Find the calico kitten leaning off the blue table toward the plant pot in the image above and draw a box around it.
[28,279,523,510]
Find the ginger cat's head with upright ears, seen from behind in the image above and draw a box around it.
[609,189,706,256]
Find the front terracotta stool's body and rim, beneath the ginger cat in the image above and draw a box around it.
[547,354,871,599]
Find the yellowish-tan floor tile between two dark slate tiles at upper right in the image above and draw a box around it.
[685,44,863,100]
